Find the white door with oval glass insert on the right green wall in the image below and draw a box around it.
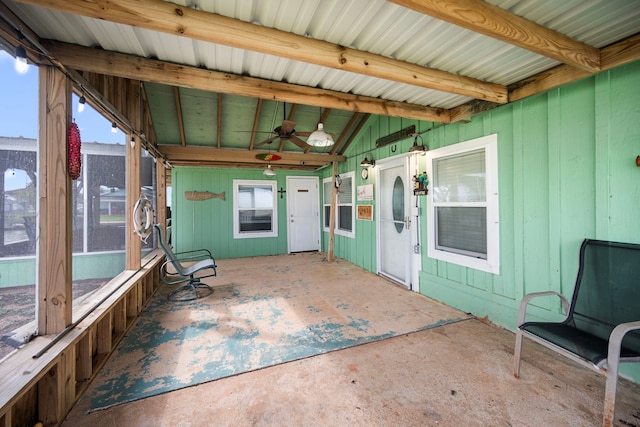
[377,159,412,287]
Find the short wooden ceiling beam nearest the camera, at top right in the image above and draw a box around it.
[391,0,600,72]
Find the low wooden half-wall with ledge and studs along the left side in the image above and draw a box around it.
[0,250,164,427]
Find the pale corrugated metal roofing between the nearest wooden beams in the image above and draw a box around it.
[8,0,640,108]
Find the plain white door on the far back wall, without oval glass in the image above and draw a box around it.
[287,176,320,252]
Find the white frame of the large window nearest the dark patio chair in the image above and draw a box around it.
[426,134,500,274]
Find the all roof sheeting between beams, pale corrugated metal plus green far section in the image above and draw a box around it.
[2,0,640,157]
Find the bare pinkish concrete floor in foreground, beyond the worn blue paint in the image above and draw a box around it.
[63,256,640,427]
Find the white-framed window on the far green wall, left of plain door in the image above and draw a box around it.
[233,180,278,239]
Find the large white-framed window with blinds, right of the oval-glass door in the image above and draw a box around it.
[427,135,500,273]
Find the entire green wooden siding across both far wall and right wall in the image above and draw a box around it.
[173,62,640,340]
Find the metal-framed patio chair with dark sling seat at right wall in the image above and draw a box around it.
[514,239,640,427]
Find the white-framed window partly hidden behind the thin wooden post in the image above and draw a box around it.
[322,172,355,237]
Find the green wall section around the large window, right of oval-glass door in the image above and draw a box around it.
[420,62,640,329]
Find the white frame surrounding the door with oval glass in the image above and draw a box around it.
[374,153,422,292]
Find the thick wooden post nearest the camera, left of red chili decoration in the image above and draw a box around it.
[36,66,73,335]
